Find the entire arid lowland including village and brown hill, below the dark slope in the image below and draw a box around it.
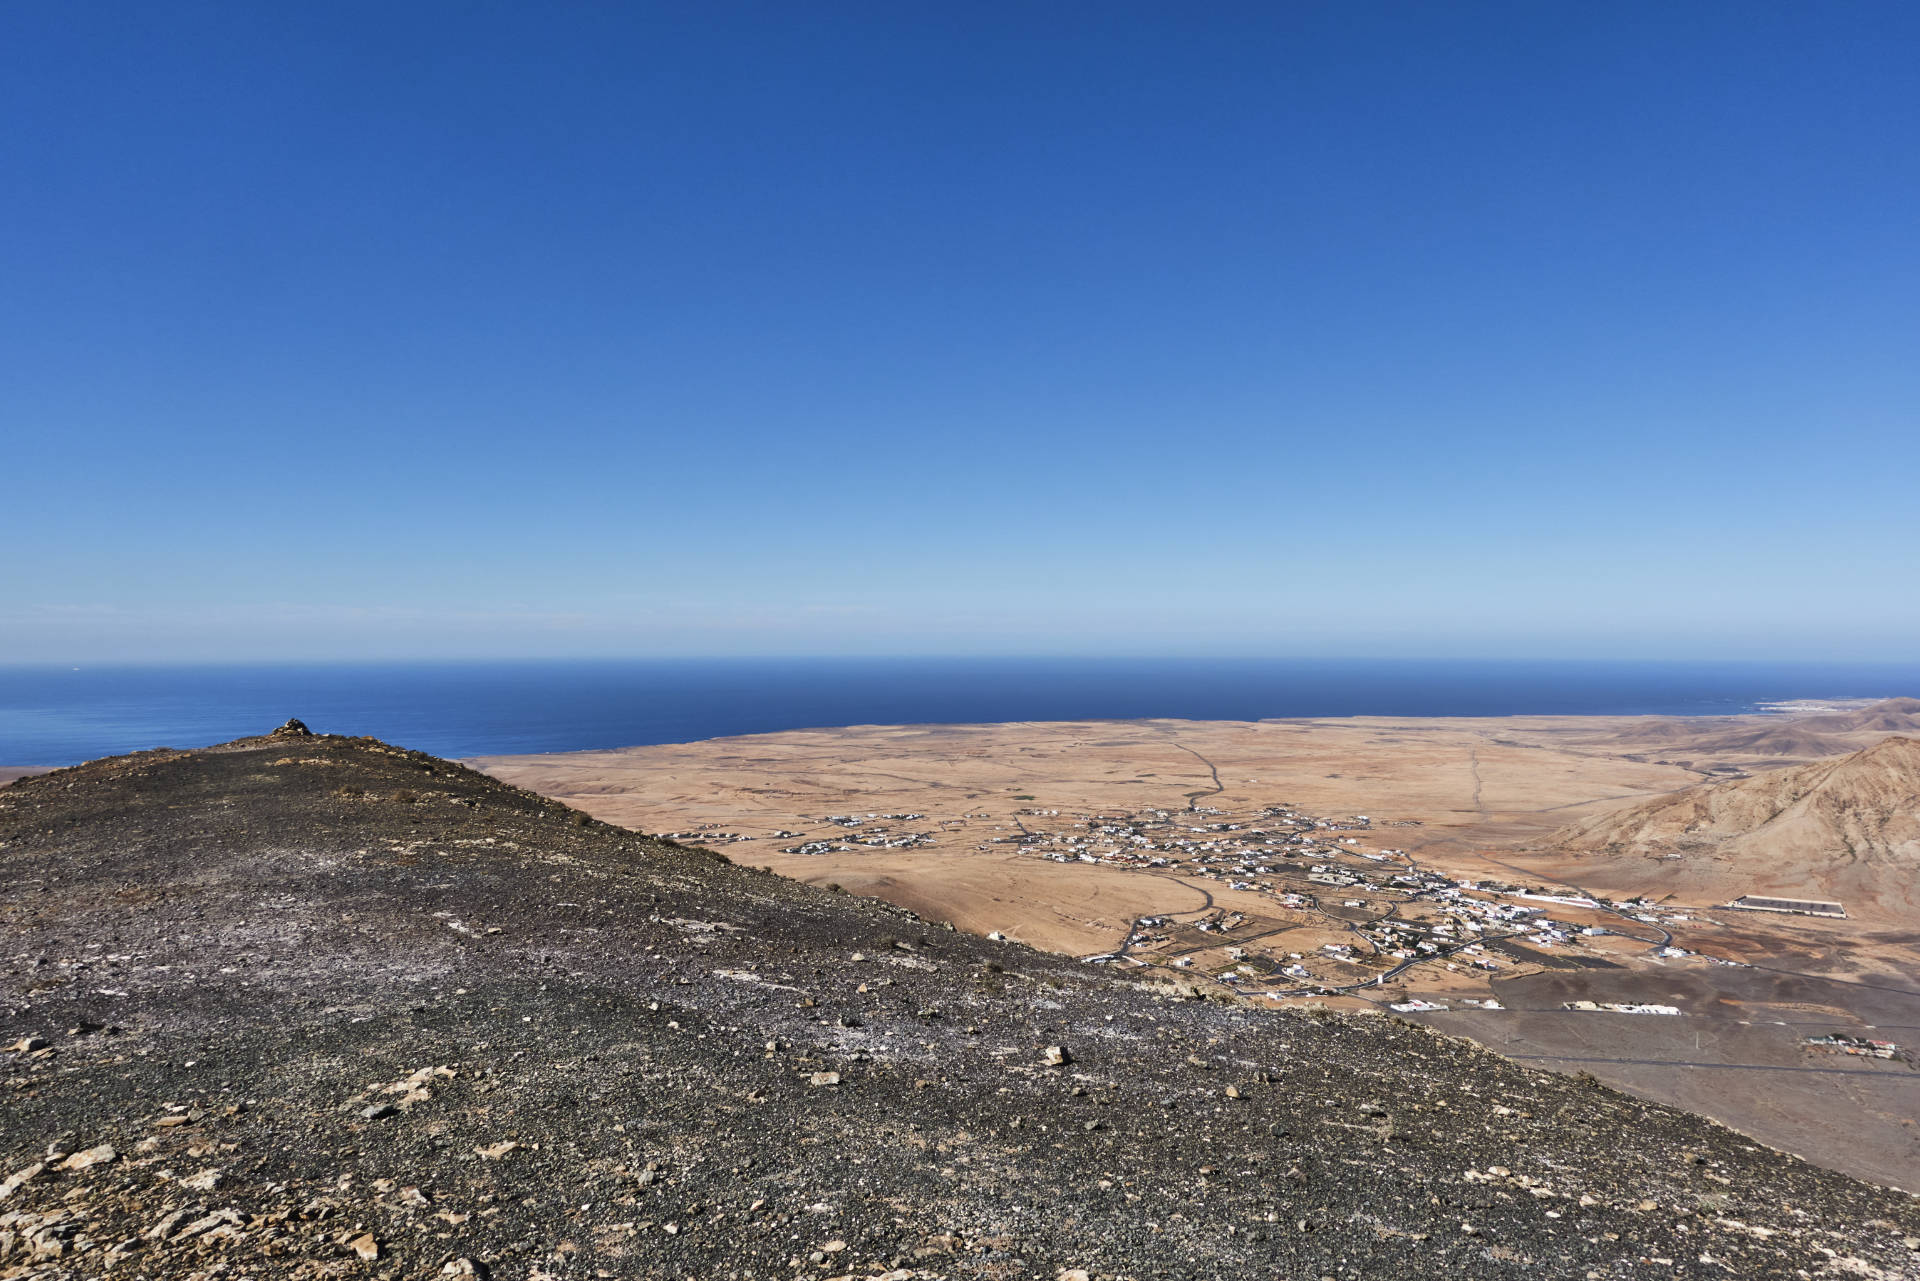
[472,699,1920,1189]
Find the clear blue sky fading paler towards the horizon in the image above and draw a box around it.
[0,0,1920,661]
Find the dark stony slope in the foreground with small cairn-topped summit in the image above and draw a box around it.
[0,736,1920,1281]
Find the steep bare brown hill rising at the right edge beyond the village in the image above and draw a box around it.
[1555,737,1920,912]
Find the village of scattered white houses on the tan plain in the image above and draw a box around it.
[668,801,1712,1010]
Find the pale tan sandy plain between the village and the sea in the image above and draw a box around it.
[472,720,1701,953]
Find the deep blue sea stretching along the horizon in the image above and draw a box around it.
[0,659,1920,764]
